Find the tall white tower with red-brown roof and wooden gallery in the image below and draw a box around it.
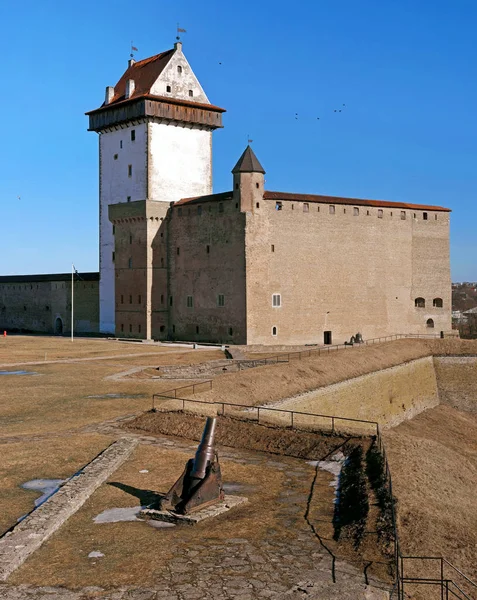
[86,42,225,333]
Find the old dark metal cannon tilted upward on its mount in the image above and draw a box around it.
[160,417,224,515]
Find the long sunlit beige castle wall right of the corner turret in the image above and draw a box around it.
[246,194,451,345]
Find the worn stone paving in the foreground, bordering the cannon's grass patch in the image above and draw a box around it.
[0,423,387,600]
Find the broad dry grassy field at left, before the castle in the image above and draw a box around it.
[0,336,223,531]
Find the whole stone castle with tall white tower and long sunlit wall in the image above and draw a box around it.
[0,42,451,345]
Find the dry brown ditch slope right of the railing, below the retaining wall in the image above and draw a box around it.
[385,405,477,581]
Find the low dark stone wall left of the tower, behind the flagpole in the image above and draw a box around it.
[0,273,99,335]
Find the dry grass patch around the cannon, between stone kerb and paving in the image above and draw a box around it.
[9,446,313,588]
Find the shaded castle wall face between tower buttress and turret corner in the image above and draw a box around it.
[168,200,246,343]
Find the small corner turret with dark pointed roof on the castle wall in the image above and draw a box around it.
[232,146,265,212]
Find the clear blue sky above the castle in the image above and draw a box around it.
[0,0,477,281]
